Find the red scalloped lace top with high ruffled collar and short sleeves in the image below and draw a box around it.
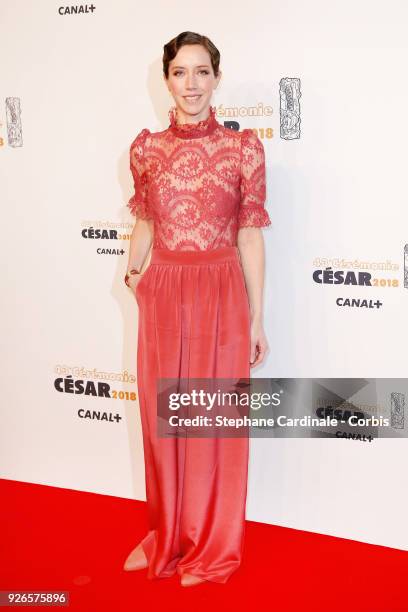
[128,106,271,250]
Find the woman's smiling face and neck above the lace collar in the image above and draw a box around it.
[164,45,221,123]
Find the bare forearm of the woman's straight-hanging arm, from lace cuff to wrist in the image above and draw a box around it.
[237,227,265,321]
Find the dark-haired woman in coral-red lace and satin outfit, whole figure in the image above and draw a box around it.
[124,32,271,586]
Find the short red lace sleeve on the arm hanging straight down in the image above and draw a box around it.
[238,128,271,229]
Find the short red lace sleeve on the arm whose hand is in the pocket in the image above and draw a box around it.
[128,128,152,219]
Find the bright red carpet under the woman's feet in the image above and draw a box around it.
[0,480,408,612]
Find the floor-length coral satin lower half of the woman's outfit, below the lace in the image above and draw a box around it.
[136,247,250,583]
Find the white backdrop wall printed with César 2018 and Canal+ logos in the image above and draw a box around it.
[0,0,408,549]
